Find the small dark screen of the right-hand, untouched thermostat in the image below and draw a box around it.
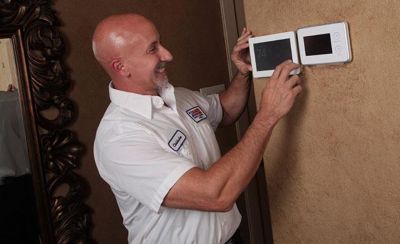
[304,34,332,56]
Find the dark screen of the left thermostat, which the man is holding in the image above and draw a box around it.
[254,39,292,71]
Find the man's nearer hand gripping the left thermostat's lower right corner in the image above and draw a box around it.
[260,60,302,124]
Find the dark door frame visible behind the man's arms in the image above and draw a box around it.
[219,0,273,244]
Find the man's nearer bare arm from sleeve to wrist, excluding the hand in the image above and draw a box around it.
[163,108,277,212]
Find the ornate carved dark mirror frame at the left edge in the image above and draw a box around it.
[0,0,90,244]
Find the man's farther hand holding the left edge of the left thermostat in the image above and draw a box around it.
[231,28,253,76]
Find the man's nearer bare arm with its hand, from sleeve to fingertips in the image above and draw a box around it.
[164,60,302,211]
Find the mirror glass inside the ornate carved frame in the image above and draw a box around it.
[0,38,39,244]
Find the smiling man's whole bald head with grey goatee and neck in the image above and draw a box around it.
[93,14,173,95]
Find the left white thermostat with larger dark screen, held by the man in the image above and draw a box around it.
[249,31,300,78]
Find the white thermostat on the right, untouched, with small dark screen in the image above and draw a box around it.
[297,22,352,65]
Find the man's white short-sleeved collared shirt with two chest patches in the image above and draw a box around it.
[94,84,241,244]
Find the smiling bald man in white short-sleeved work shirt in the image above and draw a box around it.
[93,14,301,244]
